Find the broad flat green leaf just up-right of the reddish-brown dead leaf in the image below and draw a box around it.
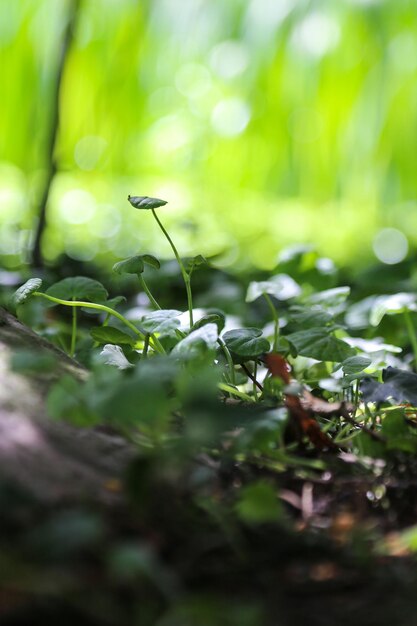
[285,328,355,363]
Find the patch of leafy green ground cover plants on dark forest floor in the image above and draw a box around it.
[5,196,417,626]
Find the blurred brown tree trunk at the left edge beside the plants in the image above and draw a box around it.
[0,308,134,504]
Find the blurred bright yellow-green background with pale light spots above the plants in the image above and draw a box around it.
[0,0,417,268]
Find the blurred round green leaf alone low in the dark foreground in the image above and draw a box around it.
[236,480,283,524]
